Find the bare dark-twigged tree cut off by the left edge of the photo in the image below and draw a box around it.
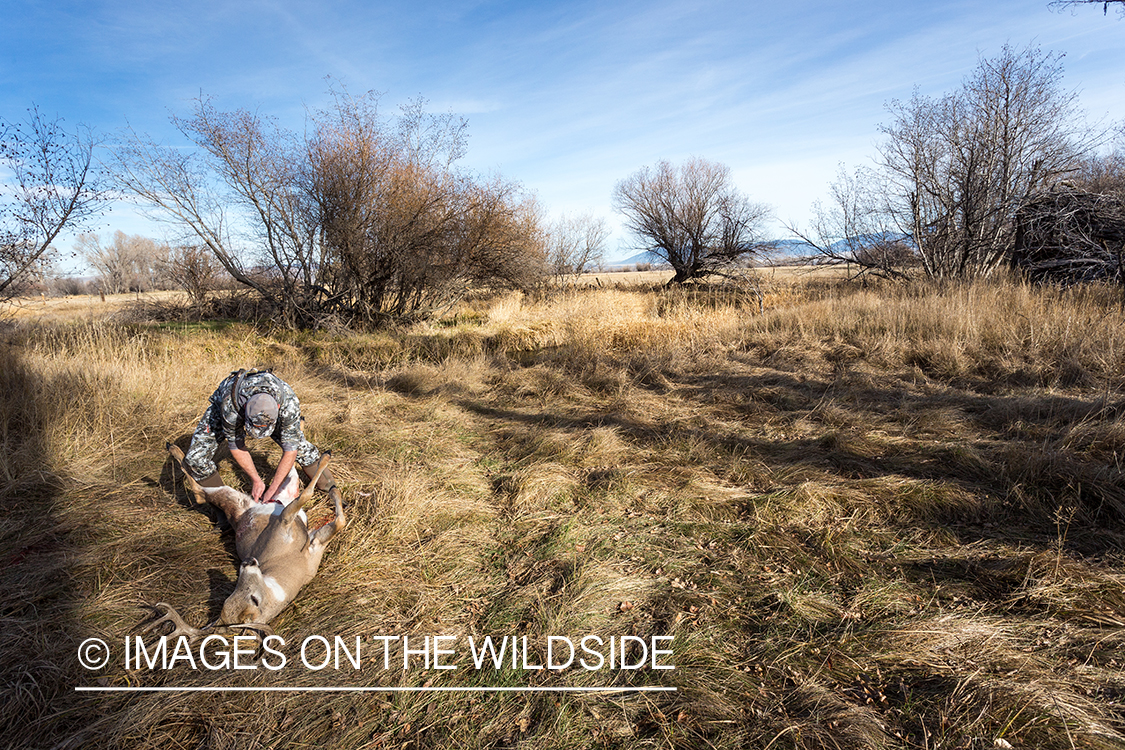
[0,107,107,299]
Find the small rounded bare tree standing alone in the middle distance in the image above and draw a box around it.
[613,159,770,284]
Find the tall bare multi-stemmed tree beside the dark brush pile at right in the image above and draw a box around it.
[879,46,1095,279]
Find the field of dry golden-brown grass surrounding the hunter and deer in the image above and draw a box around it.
[0,274,1125,750]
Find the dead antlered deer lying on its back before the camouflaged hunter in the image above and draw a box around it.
[143,444,348,640]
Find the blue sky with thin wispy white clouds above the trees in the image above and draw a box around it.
[0,0,1125,269]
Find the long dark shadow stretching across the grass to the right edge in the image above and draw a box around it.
[457,359,1125,555]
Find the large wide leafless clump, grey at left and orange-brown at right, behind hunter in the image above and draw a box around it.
[116,86,542,325]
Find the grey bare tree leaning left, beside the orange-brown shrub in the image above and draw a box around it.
[114,99,322,323]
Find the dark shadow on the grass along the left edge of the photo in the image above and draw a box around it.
[0,344,104,748]
